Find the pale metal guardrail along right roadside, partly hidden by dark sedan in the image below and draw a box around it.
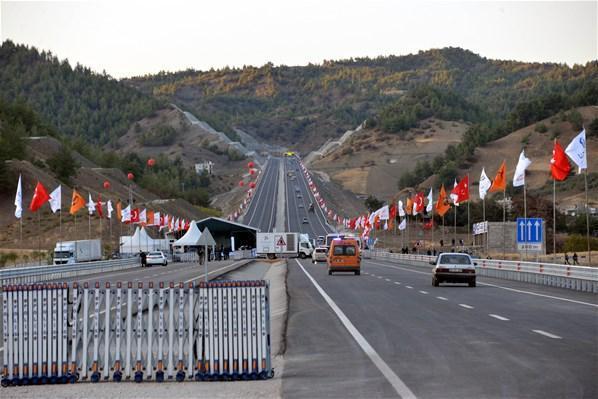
[364,250,598,294]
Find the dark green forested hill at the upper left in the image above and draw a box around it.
[0,40,162,144]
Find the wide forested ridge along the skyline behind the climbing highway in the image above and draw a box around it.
[128,48,598,150]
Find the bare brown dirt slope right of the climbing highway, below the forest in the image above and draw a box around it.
[312,119,467,198]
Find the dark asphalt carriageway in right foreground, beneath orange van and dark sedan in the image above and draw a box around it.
[283,260,598,398]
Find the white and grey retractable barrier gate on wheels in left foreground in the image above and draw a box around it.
[1,281,274,386]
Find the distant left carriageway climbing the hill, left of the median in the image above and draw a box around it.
[243,158,281,231]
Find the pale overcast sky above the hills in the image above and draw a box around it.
[0,0,598,78]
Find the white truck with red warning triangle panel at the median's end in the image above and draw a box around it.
[256,232,314,259]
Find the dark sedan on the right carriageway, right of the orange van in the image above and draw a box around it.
[430,252,477,287]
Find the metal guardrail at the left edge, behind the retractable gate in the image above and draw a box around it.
[0,258,140,286]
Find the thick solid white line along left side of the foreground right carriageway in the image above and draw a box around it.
[295,259,415,398]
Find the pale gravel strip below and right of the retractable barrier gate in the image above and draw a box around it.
[0,261,287,399]
